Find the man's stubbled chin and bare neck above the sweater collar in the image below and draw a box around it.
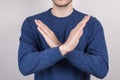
[51,0,73,17]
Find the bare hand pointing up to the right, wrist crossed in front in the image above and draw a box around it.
[59,16,90,55]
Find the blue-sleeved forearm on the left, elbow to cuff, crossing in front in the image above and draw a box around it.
[19,47,63,75]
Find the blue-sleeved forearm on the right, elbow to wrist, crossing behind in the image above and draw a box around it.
[66,50,108,78]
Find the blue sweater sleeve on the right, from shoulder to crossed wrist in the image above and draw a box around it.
[66,20,108,78]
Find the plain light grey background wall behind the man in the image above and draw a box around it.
[0,0,120,80]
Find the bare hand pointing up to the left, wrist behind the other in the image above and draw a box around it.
[35,19,61,48]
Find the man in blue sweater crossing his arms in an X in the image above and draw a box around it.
[18,0,108,80]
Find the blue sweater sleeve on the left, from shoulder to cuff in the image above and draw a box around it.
[18,18,63,75]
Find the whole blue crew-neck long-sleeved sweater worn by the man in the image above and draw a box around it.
[18,9,108,80]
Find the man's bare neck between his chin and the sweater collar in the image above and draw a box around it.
[51,3,73,17]
